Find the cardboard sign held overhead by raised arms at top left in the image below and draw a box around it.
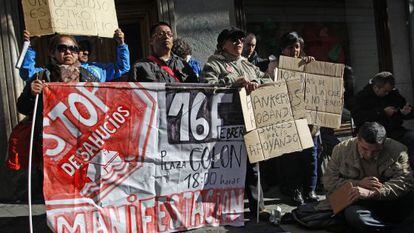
[22,0,118,38]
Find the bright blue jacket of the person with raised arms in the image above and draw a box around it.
[19,44,130,82]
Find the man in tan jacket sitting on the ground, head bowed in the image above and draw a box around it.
[323,122,414,232]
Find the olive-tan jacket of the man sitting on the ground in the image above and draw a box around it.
[322,138,414,200]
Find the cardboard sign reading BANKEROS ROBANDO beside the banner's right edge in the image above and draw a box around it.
[239,84,313,163]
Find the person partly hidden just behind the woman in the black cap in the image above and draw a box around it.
[243,33,269,72]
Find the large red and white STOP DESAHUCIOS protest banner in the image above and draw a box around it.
[43,83,247,233]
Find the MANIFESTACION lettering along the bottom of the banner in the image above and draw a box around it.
[54,189,243,233]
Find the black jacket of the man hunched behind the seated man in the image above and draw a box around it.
[351,84,414,140]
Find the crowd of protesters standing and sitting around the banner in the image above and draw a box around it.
[17,22,414,232]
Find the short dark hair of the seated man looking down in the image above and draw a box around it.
[358,122,387,144]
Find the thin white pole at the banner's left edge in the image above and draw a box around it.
[27,94,39,233]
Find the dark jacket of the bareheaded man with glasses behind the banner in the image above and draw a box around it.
[129,54,198,83]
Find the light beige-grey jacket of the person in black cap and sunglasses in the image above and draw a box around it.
[200,52,272,86]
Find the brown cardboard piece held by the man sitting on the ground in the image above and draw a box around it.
[328,182,353,214]
